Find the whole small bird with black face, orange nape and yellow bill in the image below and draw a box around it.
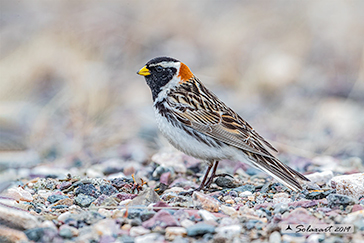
[137,57,309,192]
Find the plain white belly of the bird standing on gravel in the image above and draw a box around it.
[155,109,239,161]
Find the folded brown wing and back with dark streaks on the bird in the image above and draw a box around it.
[167,79,277,158]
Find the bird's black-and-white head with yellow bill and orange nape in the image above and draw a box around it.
[137,57,193,100]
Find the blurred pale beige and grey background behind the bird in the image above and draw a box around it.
[0,0,364,184]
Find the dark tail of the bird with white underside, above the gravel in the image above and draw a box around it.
[244,151,310,191]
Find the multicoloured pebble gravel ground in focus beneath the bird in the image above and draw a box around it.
[0,152,364,243]
